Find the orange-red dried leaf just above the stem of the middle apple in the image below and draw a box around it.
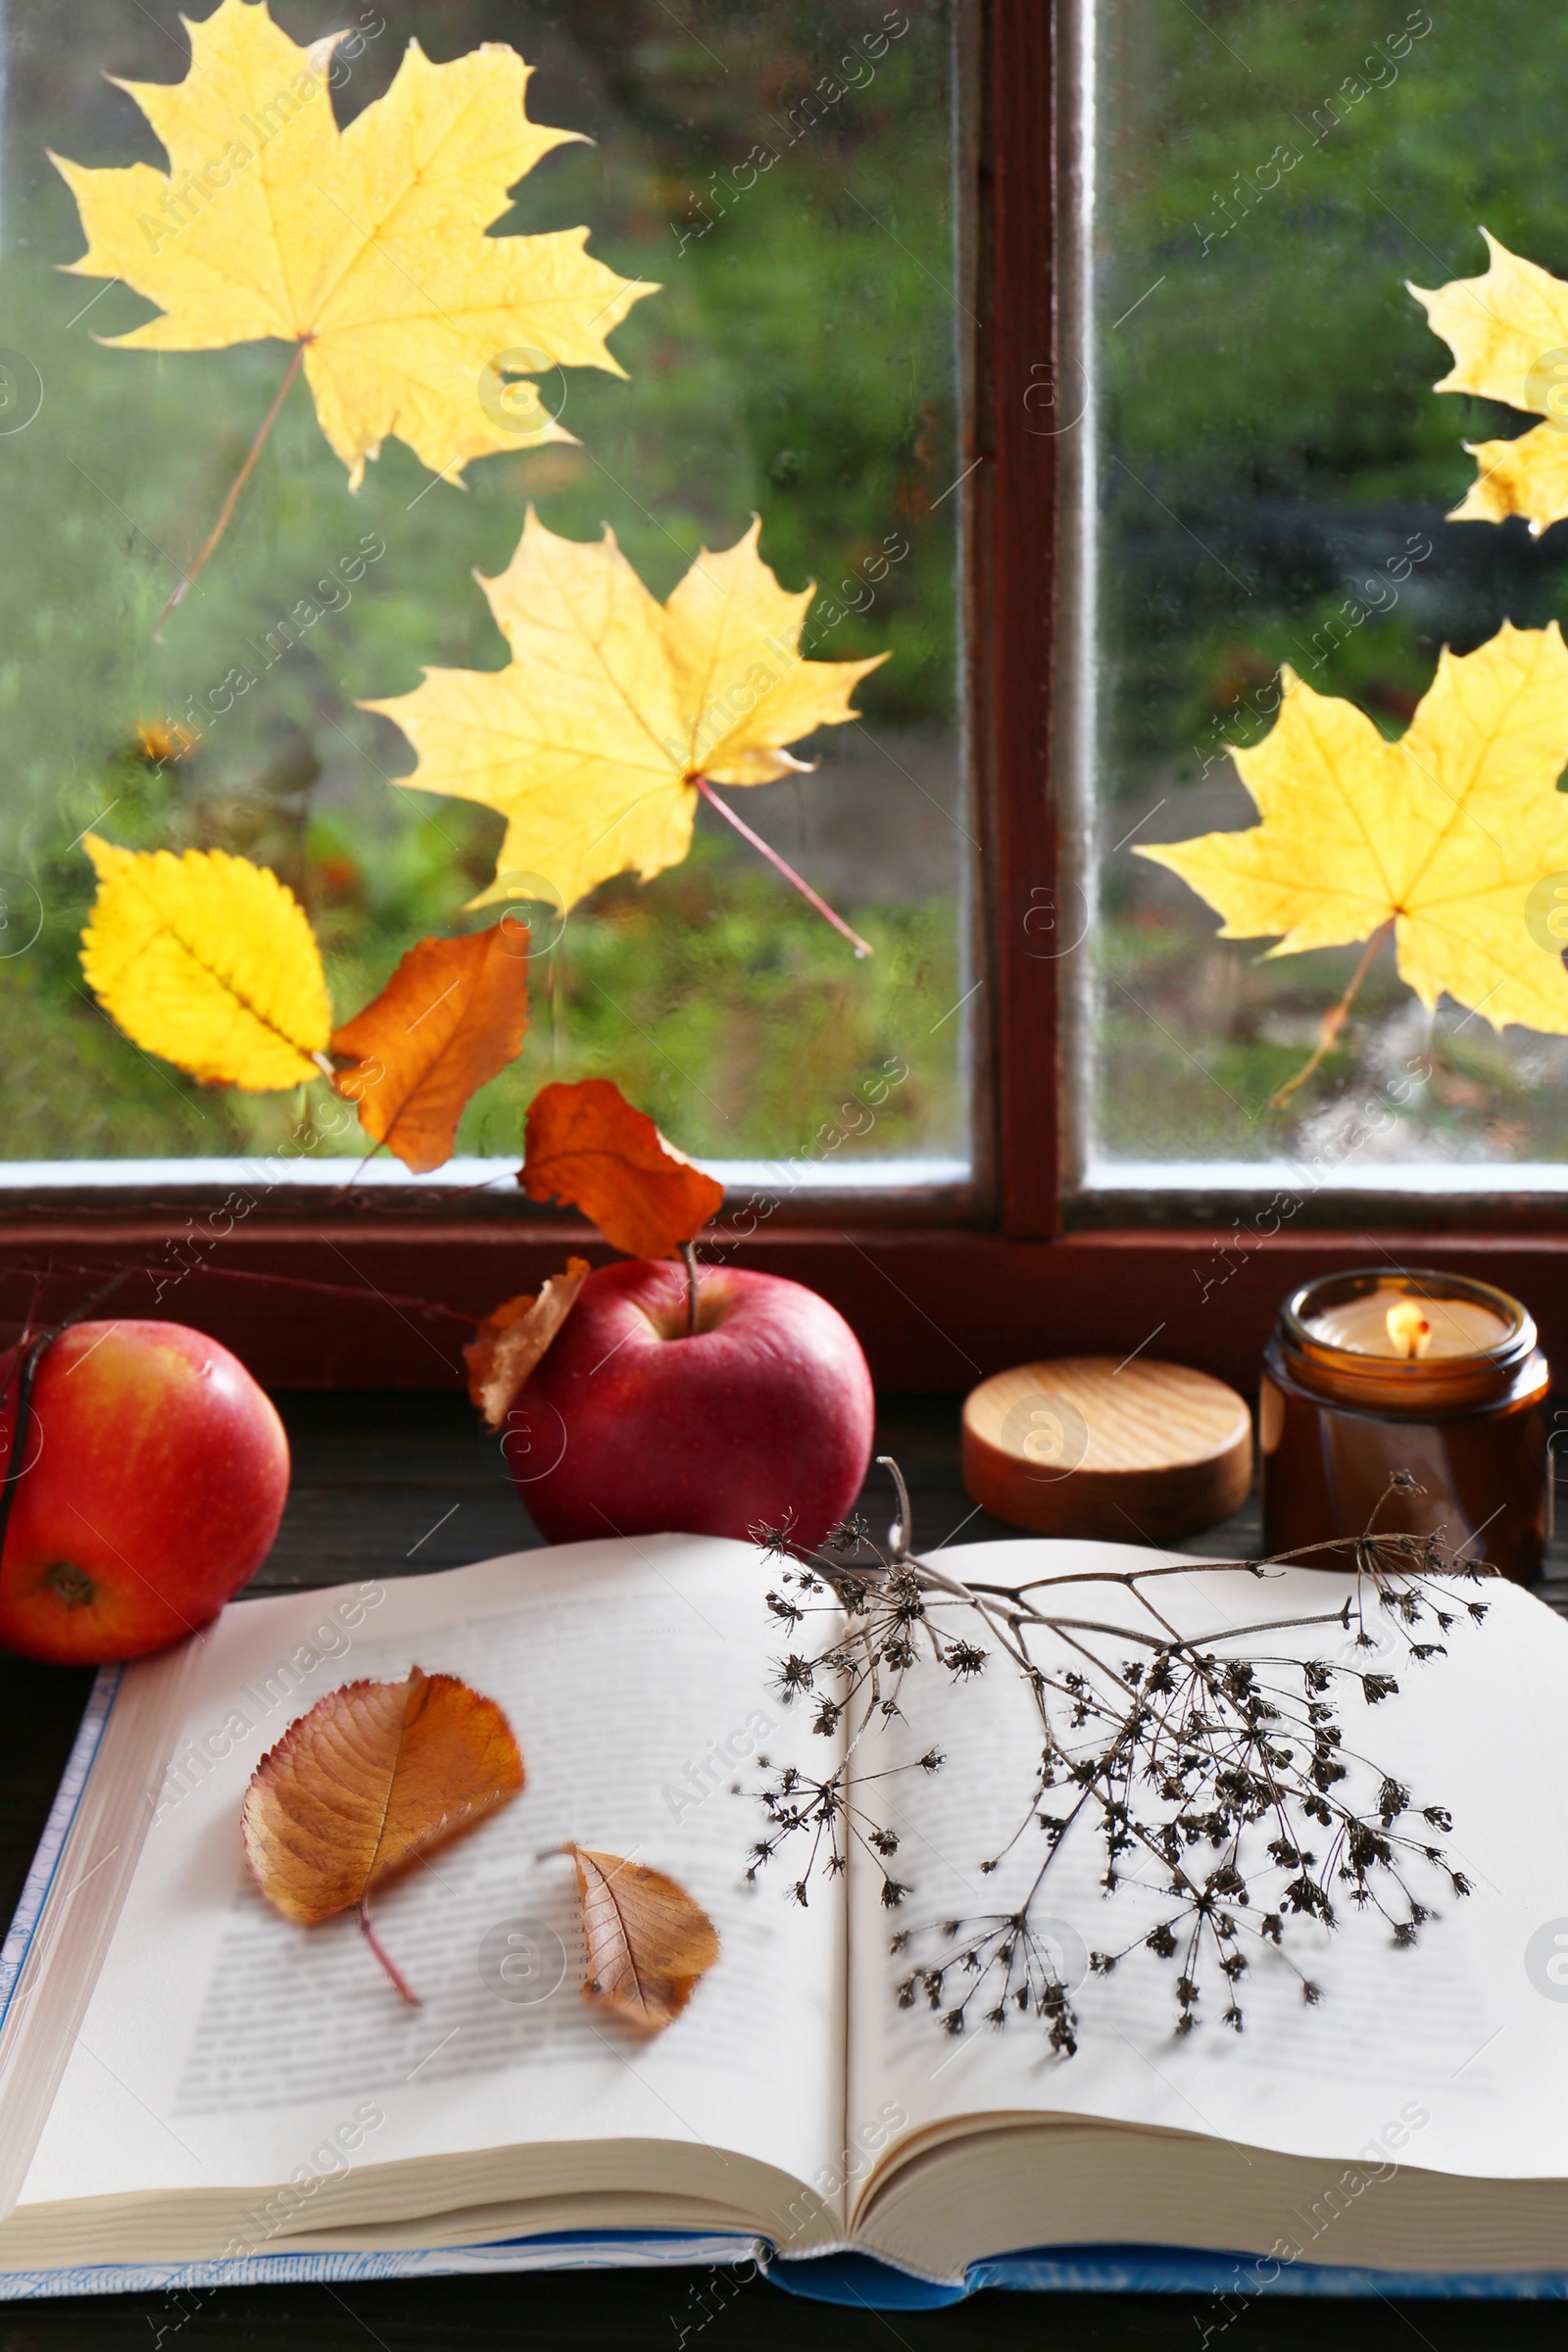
[517,1077,724,1258]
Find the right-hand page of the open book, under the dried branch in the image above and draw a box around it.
[849,1541,1568,2191]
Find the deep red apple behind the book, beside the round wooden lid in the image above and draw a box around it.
[503,1258,872,1545]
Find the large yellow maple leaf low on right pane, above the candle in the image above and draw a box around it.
[1138,621,1568,1101]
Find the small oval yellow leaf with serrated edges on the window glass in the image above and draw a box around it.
[82,833,331,1094]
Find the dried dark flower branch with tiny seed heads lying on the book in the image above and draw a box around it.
[748,1463,1493,2056]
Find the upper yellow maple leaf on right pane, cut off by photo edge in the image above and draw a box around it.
[1410,228,1568,531]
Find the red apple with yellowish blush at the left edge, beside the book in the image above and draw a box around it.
[0,1322,289,1665]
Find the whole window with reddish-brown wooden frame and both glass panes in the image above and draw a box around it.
[15,0,1568,1390]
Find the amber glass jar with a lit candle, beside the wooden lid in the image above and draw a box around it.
[1260,1268,1549,1586]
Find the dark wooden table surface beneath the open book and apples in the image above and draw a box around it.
[0,1393,1568,2352]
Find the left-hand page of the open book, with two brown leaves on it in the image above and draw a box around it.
[19,1536,844,2228]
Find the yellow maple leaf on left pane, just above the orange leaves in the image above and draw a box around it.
[365,508,886,953]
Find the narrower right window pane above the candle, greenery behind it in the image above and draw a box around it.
[1079,0,1568,1190]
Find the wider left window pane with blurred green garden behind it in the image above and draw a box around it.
[0,0,968,1181]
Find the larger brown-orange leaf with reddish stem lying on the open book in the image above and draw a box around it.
[240,1665,524,2001]
